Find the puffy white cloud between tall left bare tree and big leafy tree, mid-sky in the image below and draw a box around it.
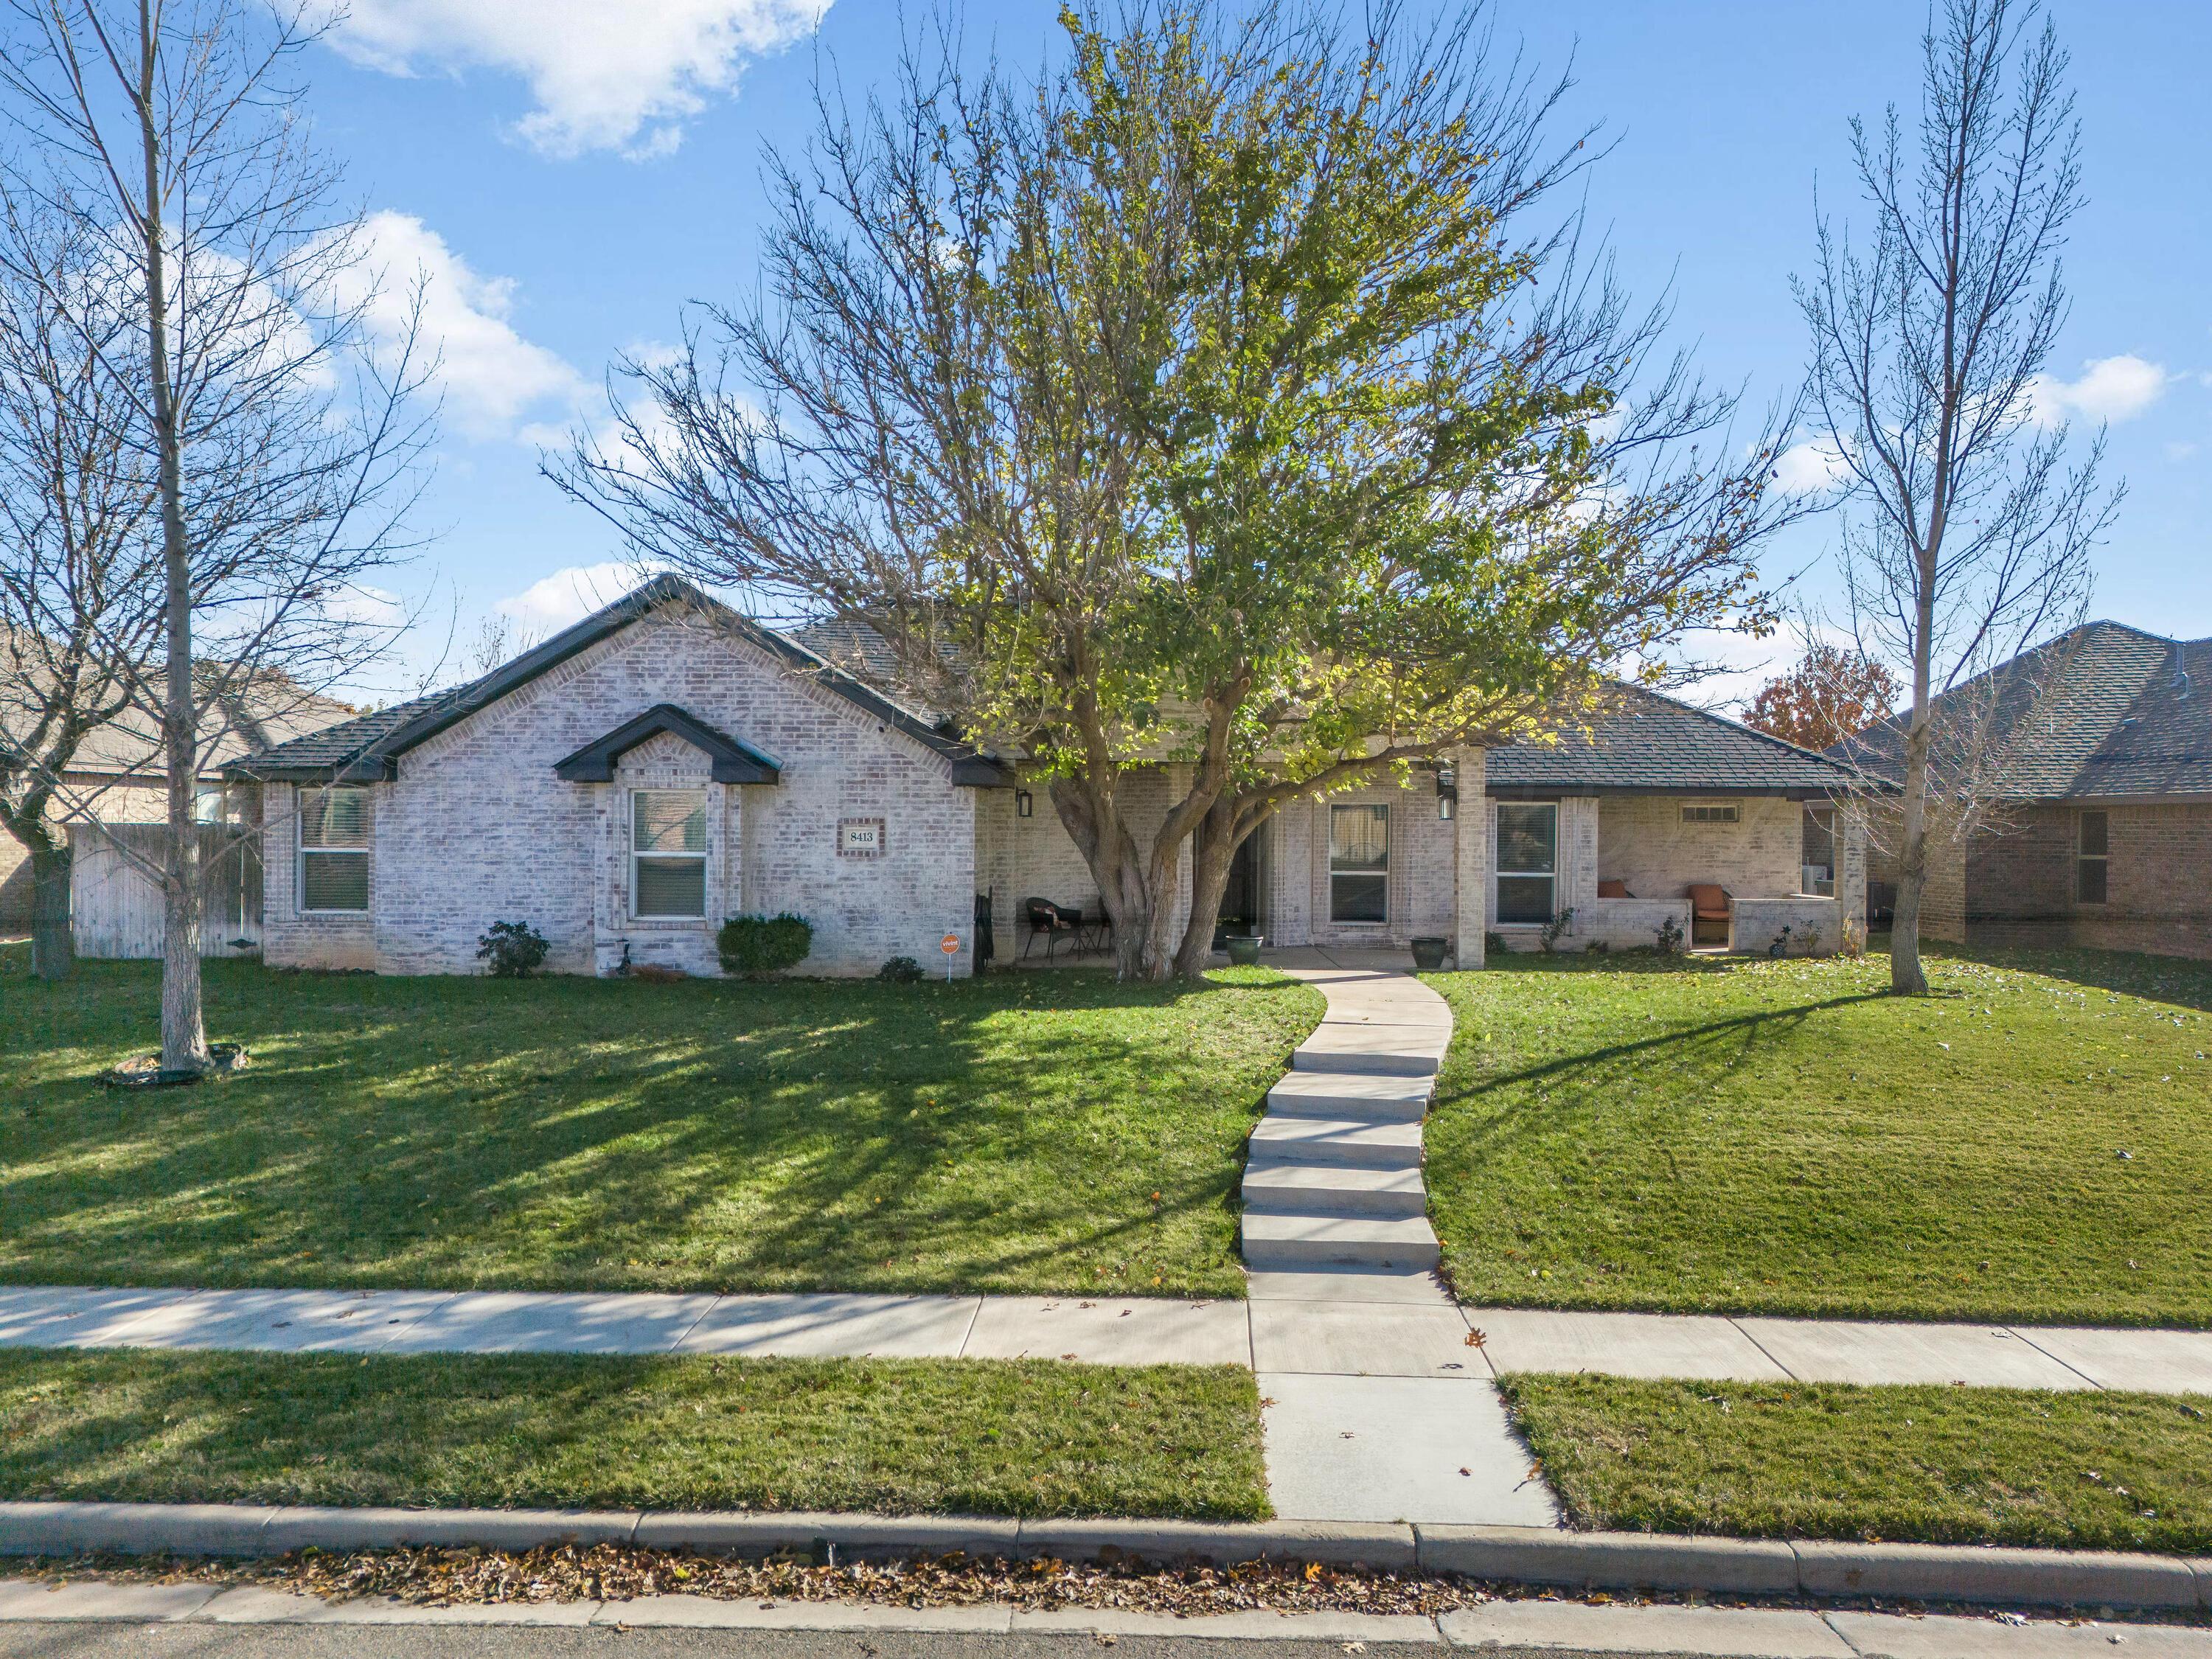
[343,212,593,449]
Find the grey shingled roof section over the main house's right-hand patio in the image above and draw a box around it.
[1484,686,1860,799]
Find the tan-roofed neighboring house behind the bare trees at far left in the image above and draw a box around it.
[0,677,354,933]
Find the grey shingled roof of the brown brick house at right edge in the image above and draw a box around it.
[1834,622,2212,801]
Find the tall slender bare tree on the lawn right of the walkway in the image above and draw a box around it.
[1796,0,2119,993]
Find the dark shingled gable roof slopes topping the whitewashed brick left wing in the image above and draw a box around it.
[228,575,1013,787]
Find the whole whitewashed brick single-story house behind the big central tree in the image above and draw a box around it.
[230,577,1863,973]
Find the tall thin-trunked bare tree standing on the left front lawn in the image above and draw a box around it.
[0,0,431,1071]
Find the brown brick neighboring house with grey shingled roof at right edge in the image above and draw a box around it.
[1836,622,2212,958]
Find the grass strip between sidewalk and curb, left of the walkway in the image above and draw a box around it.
[0,1349,1267,1520]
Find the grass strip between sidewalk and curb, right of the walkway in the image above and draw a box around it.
[1500,1376,2212,1555]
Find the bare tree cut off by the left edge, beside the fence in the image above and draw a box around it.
[0,201,161,980]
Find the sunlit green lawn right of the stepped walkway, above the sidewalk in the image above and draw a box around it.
[1427,953,2212,1325]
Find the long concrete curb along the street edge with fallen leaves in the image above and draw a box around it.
[0,1502,2212,1610]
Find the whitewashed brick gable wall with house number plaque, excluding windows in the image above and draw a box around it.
[265,617,978,973]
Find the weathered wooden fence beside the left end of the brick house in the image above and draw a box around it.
[69,823,261,958]
